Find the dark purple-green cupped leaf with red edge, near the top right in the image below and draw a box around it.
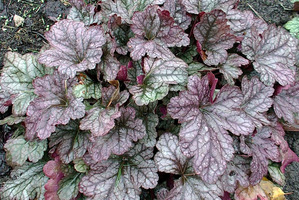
[193,10,236,65]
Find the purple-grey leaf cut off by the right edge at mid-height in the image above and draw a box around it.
[274,82,299,124]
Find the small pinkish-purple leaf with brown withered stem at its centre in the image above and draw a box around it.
[80,85,129,138]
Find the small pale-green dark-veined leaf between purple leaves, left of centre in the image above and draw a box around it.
[73,74,102,99]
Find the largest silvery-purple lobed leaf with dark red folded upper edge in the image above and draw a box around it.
[168,73,254,183]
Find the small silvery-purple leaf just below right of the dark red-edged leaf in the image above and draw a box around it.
[219,54,249,85]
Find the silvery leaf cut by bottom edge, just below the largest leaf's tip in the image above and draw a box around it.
[166,176,223,200]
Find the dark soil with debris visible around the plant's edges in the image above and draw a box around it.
[0,0,299,200]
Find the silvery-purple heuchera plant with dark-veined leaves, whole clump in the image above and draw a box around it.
[0,0,299,200]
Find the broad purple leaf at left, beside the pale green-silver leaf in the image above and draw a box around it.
[25,71,85,139]
